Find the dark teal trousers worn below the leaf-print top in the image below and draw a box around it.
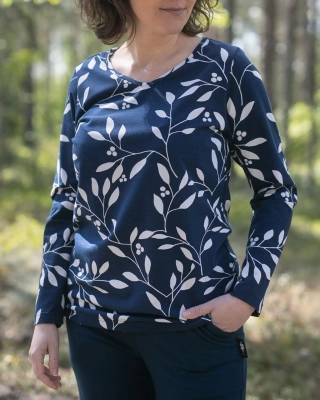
[67,320,247,400]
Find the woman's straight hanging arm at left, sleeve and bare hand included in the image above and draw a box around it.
[29,72,77,390]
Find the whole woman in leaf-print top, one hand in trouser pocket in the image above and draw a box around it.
[30,0,296,400]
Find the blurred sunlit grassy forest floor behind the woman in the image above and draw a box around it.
[0,182,320,400]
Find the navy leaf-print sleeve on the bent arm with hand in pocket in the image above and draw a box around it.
[227,49,297,316]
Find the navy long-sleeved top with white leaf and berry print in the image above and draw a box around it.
[36,38,297,331]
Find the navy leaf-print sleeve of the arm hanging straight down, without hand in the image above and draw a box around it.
[35,72,77,326]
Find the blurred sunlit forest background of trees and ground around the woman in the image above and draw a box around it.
[0,0,320,400]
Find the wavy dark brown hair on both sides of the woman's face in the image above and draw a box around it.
[75,0,219,44]
